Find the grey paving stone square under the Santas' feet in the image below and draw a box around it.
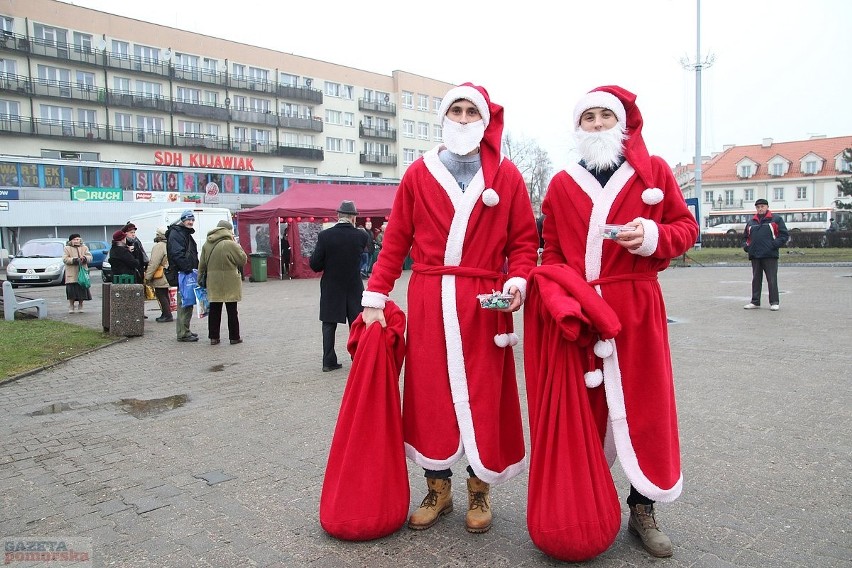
[0,267,852,568]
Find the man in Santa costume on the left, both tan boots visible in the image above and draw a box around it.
[362,83,538,533]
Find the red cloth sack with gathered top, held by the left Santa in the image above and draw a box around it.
[319,302,411,540]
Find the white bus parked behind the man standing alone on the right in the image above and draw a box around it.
[704,207,852,235]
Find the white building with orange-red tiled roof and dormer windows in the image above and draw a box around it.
[673,136,852,230]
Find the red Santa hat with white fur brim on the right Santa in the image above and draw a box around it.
[574,85,654,187]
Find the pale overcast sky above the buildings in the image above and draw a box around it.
[63,0,852,173]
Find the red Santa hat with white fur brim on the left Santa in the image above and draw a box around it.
[438,83,503,188]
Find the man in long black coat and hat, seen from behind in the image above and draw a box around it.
[310,200,367,372]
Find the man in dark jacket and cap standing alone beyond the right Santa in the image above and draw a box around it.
[743,199,790,311]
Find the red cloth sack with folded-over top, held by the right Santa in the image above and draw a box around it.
[524,266,621,562]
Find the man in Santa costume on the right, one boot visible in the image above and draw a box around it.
[540,86,698,557]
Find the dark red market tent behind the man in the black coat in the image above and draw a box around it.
[236,183,397,278]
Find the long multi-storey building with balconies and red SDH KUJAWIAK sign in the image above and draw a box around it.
[0,0,453,250]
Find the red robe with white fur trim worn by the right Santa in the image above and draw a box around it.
[542,138,698,502]
